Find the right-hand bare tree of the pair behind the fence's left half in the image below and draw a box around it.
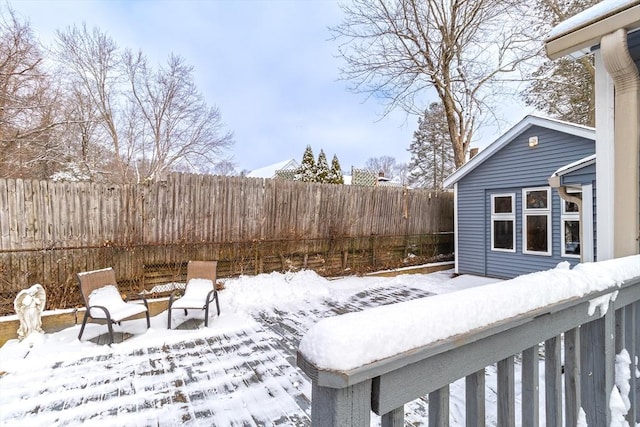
[125,52,233,179]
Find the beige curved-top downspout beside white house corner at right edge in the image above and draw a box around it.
[600,29,640,258]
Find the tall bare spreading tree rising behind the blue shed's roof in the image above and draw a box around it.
[332,0,539,167]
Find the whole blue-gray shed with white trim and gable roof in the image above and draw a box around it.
[444,115,596,278]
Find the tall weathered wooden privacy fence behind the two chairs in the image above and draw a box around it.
[0,174,453,314]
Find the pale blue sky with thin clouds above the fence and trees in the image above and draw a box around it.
[10,0,522,171]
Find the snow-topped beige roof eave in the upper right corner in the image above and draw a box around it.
[545,0,640,59]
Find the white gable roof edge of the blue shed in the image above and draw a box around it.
[443,115,596,187]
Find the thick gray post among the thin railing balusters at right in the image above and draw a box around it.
[580,304,615,426]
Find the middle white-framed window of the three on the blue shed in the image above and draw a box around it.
[522,187,552,255]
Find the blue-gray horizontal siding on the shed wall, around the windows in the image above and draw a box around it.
[456,126,595,278]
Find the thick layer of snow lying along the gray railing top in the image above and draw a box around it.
[299,255,640,371]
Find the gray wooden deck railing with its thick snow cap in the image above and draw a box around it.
[298,255,640,425]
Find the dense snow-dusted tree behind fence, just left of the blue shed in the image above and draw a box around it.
[409,102,455,190]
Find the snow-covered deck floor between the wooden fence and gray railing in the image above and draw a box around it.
[0,256,636,426]
